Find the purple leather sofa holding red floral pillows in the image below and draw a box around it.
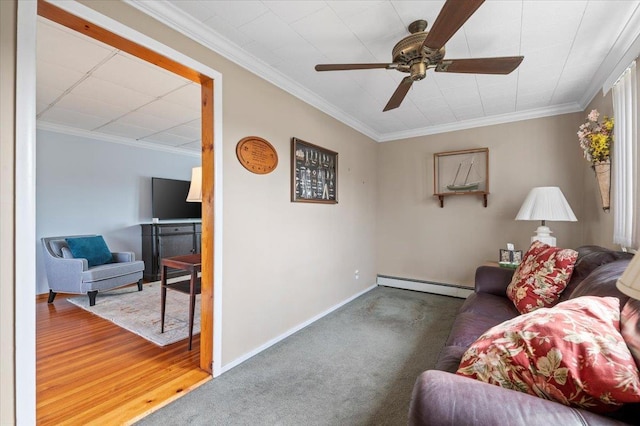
[409,246,640,426]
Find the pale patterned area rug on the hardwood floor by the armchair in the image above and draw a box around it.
[67,277,200,346]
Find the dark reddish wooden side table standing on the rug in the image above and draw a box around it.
[160,254,202,350]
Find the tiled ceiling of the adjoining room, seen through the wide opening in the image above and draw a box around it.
[36,18,201,153]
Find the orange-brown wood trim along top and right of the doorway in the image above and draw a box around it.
[38,0,215,375]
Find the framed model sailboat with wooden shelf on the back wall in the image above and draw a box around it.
[433,148,489,205]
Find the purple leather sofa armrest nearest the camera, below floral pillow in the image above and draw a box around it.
[409,370,625,426]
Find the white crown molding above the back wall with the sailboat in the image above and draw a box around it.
[378,103,584,142]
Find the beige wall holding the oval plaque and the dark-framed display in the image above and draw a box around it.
[79,1,378,366]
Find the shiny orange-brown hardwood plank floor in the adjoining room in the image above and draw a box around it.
[36,288,210,425]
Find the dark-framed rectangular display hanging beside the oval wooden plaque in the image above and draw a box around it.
[291,137,338,204]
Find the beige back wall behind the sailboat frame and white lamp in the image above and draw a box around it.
[377,114,584,286]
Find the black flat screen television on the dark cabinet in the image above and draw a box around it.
[151,177,202,220]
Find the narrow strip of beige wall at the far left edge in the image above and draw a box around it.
[0,1,17,425]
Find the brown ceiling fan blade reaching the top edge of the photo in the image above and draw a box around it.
[422,0,484,50]
